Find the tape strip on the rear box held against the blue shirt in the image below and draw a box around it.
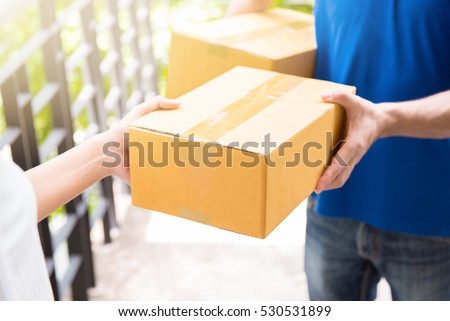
[208,21,312,57]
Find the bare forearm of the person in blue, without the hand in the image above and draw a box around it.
[380,90,450,138]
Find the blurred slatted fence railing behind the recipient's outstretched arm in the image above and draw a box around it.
[0,0,157,300]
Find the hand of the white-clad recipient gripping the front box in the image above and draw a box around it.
[103,96,180,183]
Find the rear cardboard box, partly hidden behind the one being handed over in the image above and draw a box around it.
[166,9,316,98]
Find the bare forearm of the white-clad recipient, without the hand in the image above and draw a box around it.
[26,133,108,221]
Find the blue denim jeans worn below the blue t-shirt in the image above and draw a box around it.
[305,198,450,301]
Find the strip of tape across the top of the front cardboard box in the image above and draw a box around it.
[181,74,303,142]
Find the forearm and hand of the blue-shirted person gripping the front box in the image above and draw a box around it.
[316,90,450,193]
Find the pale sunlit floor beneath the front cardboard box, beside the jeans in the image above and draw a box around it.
[90,195,390,301]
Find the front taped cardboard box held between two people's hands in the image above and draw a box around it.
[129,67,355,238]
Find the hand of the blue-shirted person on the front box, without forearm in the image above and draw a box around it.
[316,91,385,193]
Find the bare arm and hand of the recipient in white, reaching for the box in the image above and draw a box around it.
[26,97,178,221]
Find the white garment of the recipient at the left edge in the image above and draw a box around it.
[0,155,53,301]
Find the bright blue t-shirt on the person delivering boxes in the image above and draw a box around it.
[315,0,450,236]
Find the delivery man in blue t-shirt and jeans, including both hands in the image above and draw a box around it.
[228,0,450,300]
